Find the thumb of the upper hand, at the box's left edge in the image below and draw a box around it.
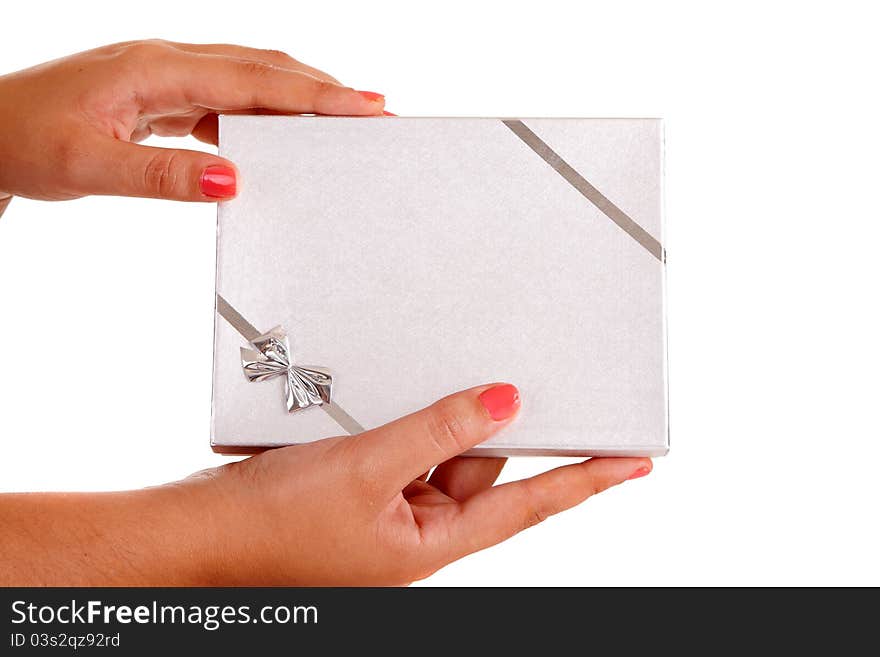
[77,139,238,201]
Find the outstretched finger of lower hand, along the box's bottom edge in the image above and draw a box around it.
[438,458,652,560]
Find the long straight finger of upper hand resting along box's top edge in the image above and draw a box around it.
[161,53,385,116]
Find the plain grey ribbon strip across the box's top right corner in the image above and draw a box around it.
[502,119,666,262]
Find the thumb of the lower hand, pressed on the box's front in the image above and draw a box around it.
[351,384,520,493]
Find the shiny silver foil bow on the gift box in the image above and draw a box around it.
[241,326,333,413]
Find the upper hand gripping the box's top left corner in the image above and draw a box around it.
[0,40,385,204]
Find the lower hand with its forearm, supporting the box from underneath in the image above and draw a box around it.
[0,385,651,585]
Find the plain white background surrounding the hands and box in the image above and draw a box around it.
[0,0,880,585]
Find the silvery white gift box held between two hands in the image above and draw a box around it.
[211,116,668,456]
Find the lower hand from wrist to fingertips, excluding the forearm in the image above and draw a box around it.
[196,384,652,586]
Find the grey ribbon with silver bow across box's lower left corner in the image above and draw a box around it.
[217,294,364,435]
